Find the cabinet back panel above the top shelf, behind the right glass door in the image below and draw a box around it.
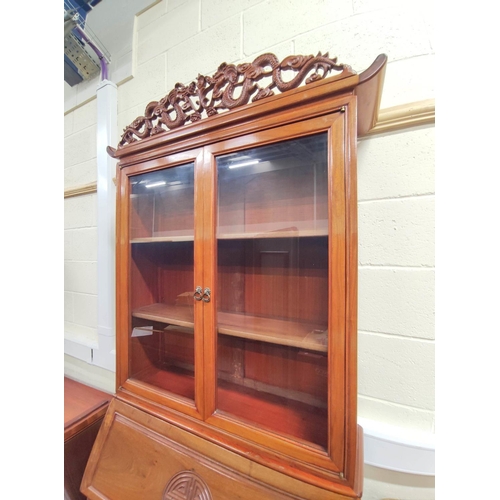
[217,133,328,238]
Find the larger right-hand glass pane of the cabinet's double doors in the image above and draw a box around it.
[217,133,328,448]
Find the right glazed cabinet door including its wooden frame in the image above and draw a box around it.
[206,112,345,470]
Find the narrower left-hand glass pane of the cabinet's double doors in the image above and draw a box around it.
[129,163,195,400]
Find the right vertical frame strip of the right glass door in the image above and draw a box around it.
[328,110,346,472]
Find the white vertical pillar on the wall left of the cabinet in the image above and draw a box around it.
[92,80,118,371]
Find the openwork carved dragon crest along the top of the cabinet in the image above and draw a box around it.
[118,52,355,148]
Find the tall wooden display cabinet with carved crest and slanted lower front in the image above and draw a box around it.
[82,50,387,500]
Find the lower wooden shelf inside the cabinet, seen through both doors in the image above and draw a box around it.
[132,304,328,352]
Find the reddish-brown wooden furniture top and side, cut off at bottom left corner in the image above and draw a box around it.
[64,377,111,500]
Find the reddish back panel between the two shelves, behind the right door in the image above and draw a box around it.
[217,237,328,325]
